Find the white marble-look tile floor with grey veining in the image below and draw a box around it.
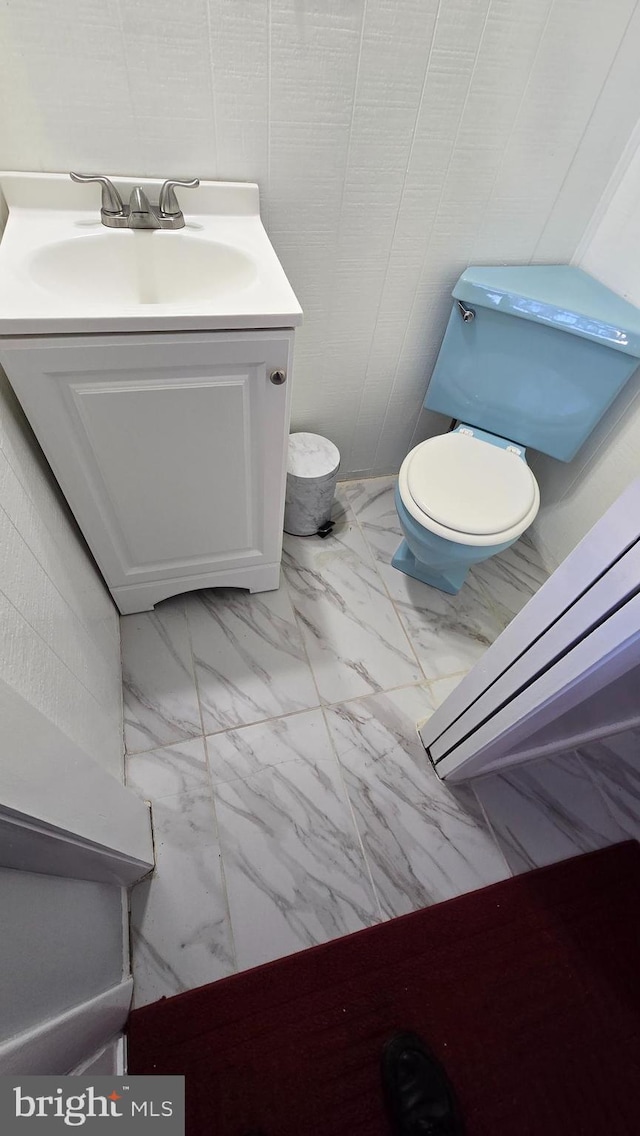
[122,477,640,1005]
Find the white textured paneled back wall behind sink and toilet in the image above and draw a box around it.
[0,0,640,474]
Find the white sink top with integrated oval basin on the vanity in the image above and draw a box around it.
[0,174,301,335]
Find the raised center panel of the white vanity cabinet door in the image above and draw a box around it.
[69,368,256,571]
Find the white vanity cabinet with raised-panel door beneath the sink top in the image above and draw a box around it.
[0,329,293,613]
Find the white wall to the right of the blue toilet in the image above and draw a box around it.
[532,128,640,567]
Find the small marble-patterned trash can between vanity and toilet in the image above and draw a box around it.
[284,434,340,536]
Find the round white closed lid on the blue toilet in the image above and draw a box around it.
[407,432,535,535]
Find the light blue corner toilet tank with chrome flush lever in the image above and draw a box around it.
[424,265,640,461]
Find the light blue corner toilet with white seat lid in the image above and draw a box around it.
[391,265,640,594]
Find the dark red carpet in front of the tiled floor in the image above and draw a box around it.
[128,842,640,1136]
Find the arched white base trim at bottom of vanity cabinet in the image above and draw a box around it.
[109,560,280,616]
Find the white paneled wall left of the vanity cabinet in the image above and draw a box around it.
[0,374,123,780]
